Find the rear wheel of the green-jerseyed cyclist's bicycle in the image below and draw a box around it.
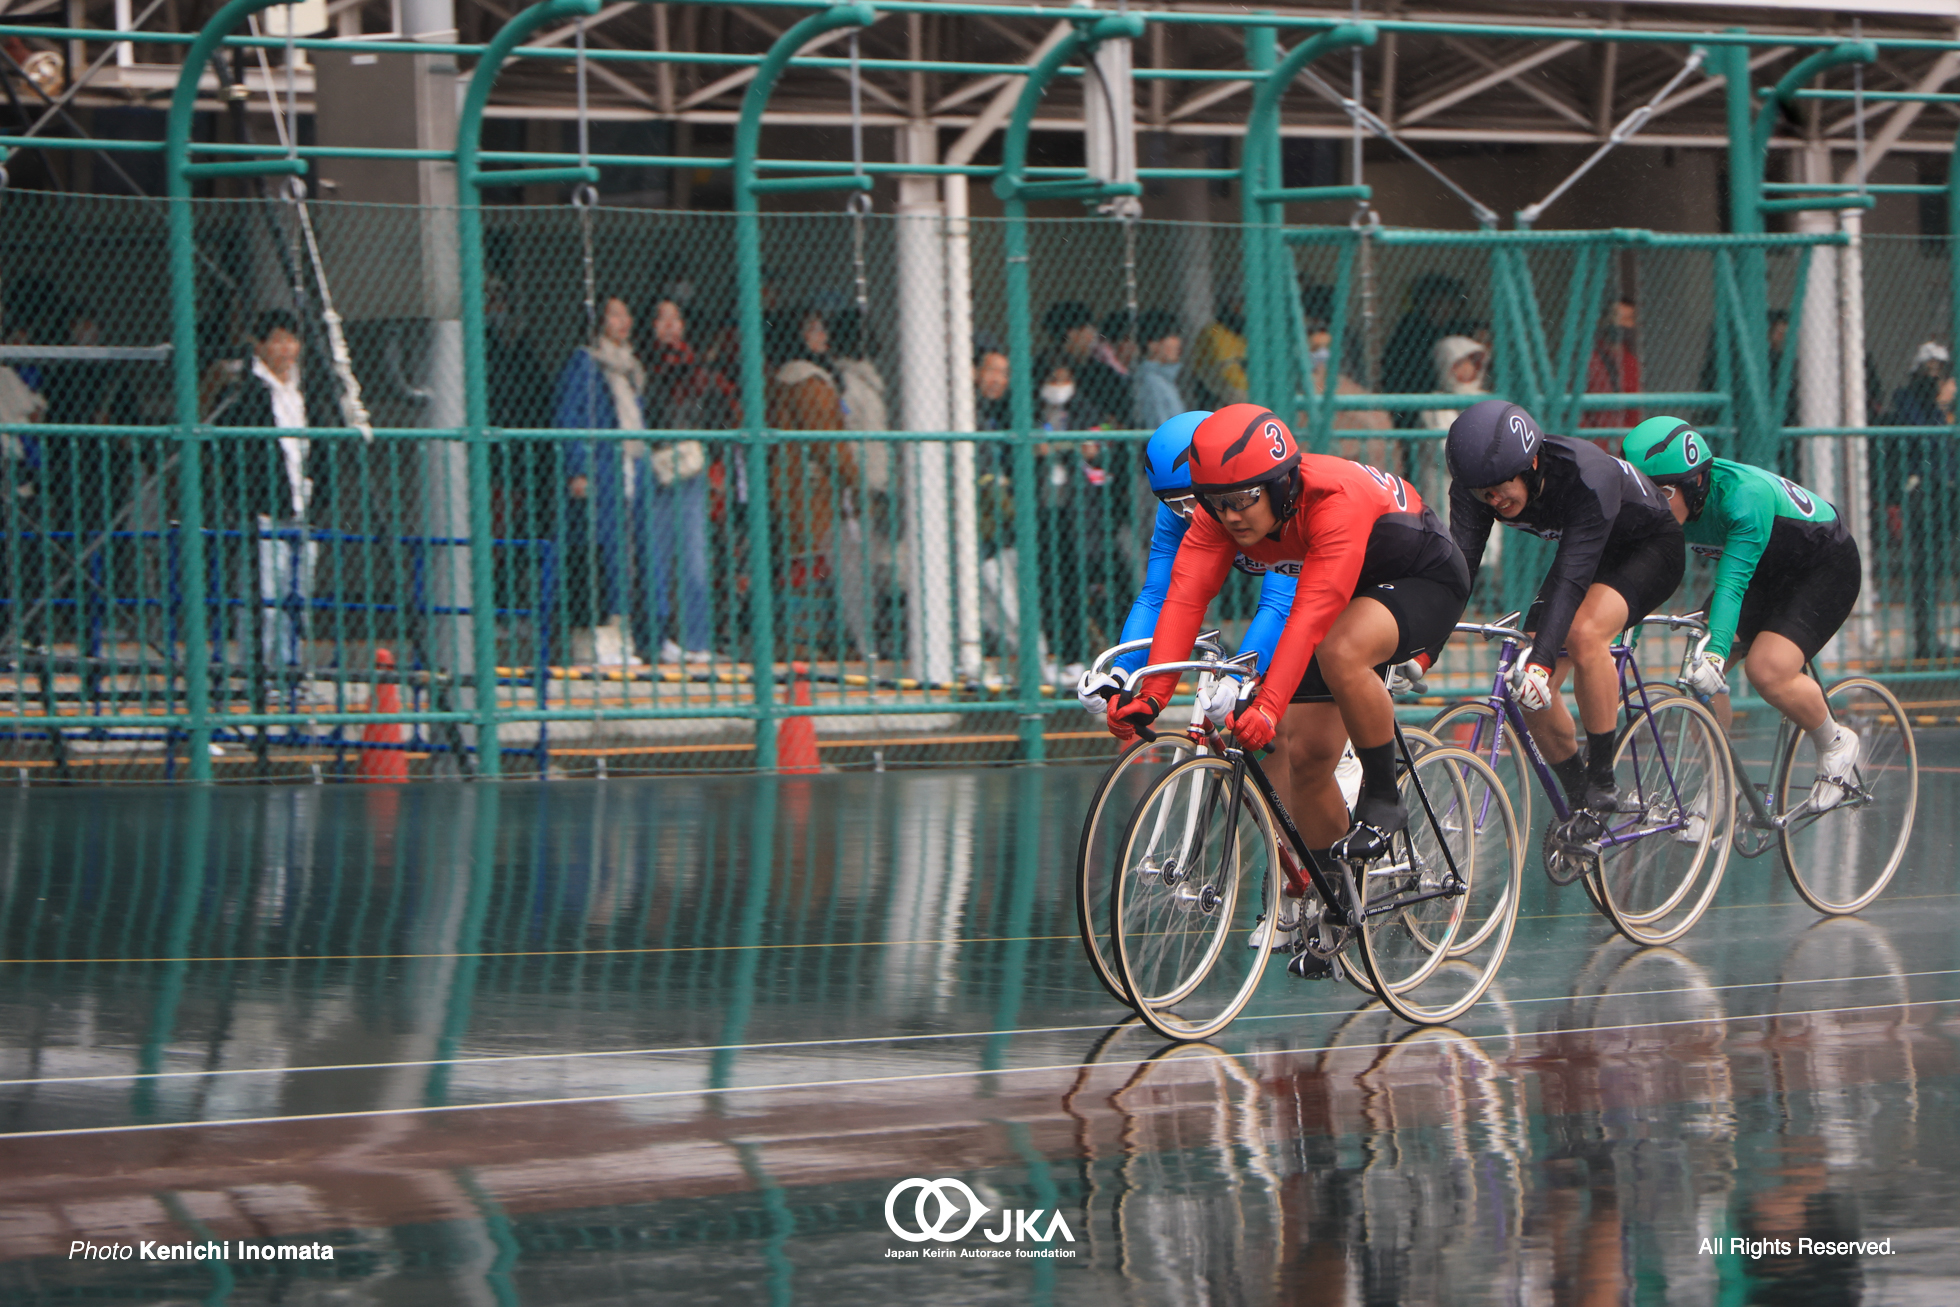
[1770,676,1919,917]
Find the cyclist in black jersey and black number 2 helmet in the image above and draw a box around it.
[1445,400,1688,811]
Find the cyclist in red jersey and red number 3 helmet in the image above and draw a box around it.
[1109,404,1470,864]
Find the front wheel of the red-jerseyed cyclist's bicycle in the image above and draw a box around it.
[1109,756,1280,1039]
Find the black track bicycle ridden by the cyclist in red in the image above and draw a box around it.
[1109,660,1525,1041]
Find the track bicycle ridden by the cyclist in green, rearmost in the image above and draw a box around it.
[1676,613,1919,917]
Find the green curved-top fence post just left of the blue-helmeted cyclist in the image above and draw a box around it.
[994,10,1143,762]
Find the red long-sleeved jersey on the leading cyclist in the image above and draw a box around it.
[1143,455,1470,721]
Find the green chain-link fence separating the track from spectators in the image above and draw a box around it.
[0,192,1960,780]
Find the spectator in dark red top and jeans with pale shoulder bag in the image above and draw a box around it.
[633,300,741,662]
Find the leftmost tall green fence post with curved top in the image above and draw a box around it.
[163,0,309,780]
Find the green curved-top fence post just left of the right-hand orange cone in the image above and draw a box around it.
[735,4,878,772]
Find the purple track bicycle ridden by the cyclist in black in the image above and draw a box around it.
[1429,613,1735,944]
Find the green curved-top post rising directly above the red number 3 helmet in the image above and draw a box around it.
[1239,24,1376,415]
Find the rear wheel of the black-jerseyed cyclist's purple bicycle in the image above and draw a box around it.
[1593,696,1735,944]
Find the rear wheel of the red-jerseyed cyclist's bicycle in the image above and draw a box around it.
[1356,747,1525,1025]
